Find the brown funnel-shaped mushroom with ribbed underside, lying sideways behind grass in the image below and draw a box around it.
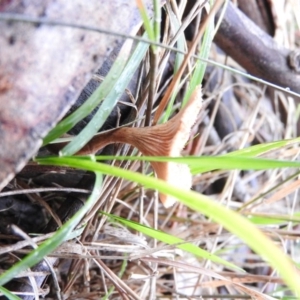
[77,86,202,207]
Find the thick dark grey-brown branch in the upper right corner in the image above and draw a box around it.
[214,2,300,95]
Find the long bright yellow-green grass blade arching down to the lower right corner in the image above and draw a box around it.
[36,157,300,295]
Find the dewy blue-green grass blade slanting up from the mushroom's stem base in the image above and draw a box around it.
[60,36,148,156]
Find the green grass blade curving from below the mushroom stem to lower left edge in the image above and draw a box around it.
[0,172,102,286]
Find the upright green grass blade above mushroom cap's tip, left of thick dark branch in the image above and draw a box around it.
[182,1,215,106]
